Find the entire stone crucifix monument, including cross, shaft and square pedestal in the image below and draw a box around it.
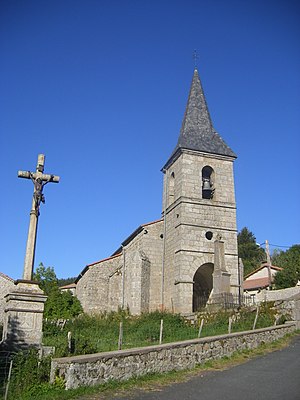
[3,154,59,348]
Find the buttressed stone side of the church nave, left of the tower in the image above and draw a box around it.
[76,220,163,314]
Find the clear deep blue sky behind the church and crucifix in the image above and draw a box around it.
[0,0,300,279]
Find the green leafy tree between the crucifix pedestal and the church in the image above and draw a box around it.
[34,263,83,319]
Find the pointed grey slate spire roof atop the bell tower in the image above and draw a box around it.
[166,69,236,169]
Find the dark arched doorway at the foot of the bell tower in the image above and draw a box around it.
[193,263,214,312]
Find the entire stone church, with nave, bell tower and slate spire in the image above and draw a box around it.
[76,69,241,314]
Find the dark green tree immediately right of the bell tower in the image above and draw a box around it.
[238,227,266,276]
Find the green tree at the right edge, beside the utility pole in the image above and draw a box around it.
[272,244,300,289]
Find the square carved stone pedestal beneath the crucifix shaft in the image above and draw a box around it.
[2,280,47,348]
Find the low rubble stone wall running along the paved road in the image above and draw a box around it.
[51,322,296,389]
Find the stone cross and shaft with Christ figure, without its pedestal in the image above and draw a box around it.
[18,154,59,281]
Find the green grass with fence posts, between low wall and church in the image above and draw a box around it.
[43,306,275,357]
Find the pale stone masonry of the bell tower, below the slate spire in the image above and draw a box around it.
[163,151,238,313]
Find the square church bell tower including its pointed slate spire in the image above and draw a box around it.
[162,69,239,313]
